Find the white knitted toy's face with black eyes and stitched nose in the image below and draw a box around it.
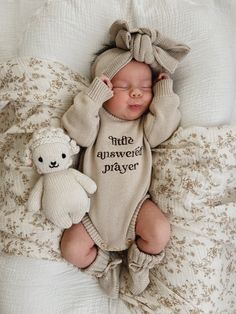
[32,143,72,173]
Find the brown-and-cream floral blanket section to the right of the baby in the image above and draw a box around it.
[123,126,236,314]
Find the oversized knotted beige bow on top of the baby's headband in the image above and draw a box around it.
[110,20,190,73]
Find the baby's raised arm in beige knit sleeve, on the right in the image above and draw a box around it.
[144,73,180,147]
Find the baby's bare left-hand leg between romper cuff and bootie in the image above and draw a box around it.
[61,223,97,268]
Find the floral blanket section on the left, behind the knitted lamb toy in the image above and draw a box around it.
[0,58,88,260]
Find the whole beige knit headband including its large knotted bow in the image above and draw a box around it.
[91,20,190,79]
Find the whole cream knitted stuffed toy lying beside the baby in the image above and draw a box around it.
[27,128,97,228]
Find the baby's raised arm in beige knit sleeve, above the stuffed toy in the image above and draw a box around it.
[62,77,113,147]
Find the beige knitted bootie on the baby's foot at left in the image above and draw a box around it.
[83,249,122,299]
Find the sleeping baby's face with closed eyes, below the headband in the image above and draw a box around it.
[104,61,153,120]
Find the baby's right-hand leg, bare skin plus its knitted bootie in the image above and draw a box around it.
[128,200,170,295]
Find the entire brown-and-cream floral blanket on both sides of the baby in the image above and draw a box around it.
[0,58,236,314]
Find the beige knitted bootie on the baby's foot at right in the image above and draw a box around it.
[128,242,164,295]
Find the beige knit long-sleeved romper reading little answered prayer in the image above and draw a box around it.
[62,78,180,251]
